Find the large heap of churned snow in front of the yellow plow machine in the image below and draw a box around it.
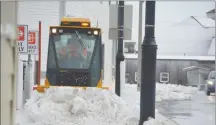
[16,87,175,125]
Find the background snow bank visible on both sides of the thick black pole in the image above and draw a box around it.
[122,83,198,105]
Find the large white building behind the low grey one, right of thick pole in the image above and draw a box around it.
[156,16,215,56]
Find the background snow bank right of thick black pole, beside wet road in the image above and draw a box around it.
[156,83,198,101]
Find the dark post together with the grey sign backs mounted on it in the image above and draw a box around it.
[108,1,133,96]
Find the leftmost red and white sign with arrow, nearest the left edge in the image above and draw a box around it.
[17,25,28,54]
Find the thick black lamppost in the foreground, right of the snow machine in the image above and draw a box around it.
[139,1,157,125]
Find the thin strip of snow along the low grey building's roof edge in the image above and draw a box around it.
[124,54,215,61]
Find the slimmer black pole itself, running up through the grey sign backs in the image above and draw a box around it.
[115,1,124,96]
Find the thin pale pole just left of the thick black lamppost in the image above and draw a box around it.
[137,1,143,91]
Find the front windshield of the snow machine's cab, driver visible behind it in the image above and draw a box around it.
[53,31,96,69]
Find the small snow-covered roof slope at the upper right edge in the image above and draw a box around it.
[192,16,215,28]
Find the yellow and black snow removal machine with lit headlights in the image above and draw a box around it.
[34,17,109,92]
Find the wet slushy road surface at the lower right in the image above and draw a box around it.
[156,92,215,125]
